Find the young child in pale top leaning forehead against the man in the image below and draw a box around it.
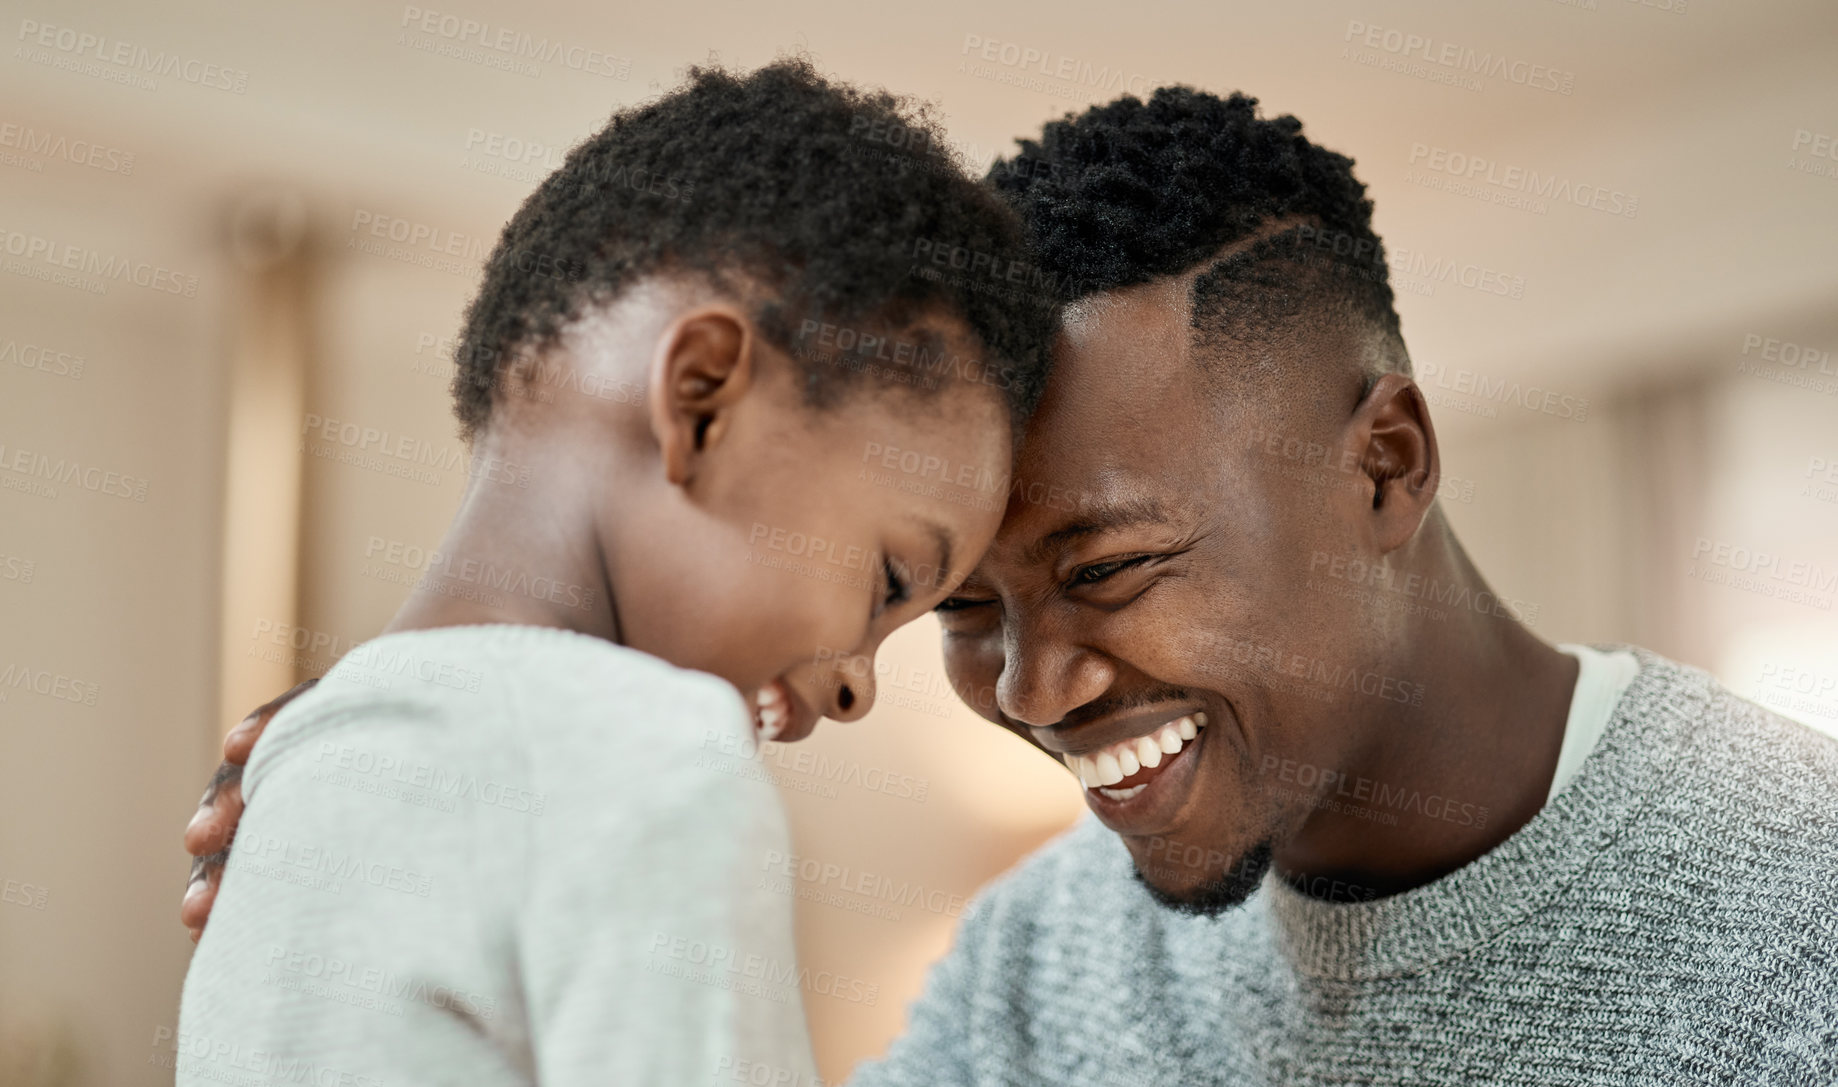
[176,61,1051,1087]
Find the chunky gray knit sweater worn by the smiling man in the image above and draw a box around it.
[851,653,1838,1087]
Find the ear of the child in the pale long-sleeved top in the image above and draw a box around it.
[647,305,759,486]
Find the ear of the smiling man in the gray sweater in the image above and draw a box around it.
[1347,373,1443,554]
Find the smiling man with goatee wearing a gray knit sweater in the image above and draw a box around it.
[175,88,1838,1087]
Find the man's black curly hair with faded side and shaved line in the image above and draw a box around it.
[989,86,1410,386]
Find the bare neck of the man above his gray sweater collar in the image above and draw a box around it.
[1276,524,1577,898]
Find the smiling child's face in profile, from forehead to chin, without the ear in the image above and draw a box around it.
[705,375,1011,741]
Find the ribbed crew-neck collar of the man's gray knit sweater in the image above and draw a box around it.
[1263,646,1709,980]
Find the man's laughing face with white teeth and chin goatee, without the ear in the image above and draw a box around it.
[939,278,1371,909]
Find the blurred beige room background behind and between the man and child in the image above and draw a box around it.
[0,0,1838,1085]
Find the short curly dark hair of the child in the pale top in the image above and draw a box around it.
[452,57,1055,441]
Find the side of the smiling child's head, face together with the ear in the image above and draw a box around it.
[603,303,1011,741]
